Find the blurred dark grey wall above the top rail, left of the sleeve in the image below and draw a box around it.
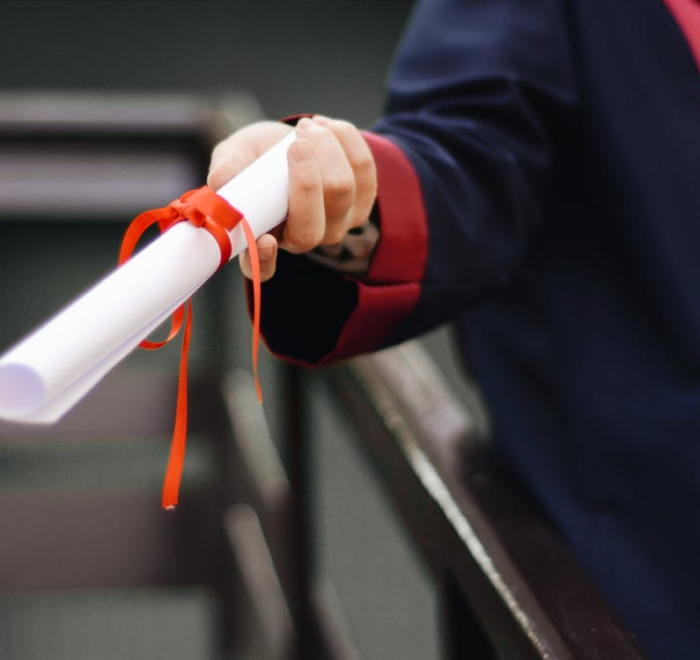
[0,0,412,125]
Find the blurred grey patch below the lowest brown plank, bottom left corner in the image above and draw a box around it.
[0,589,222,660]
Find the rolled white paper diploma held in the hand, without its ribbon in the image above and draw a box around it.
[0,133,294,424]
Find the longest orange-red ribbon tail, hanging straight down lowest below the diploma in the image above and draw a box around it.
[163,300,192,510]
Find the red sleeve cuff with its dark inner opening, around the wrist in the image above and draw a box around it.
[249,132,428,366]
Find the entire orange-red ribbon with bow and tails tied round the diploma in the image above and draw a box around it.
[119,186,262,509]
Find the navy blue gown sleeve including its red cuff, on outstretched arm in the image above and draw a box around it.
[254,0,576,364]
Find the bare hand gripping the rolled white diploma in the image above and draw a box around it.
[207,116,377,281]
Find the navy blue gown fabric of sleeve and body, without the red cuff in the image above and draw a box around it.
[375,0,700,660]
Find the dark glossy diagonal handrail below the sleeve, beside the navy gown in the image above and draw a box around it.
[331,343,643,659]
